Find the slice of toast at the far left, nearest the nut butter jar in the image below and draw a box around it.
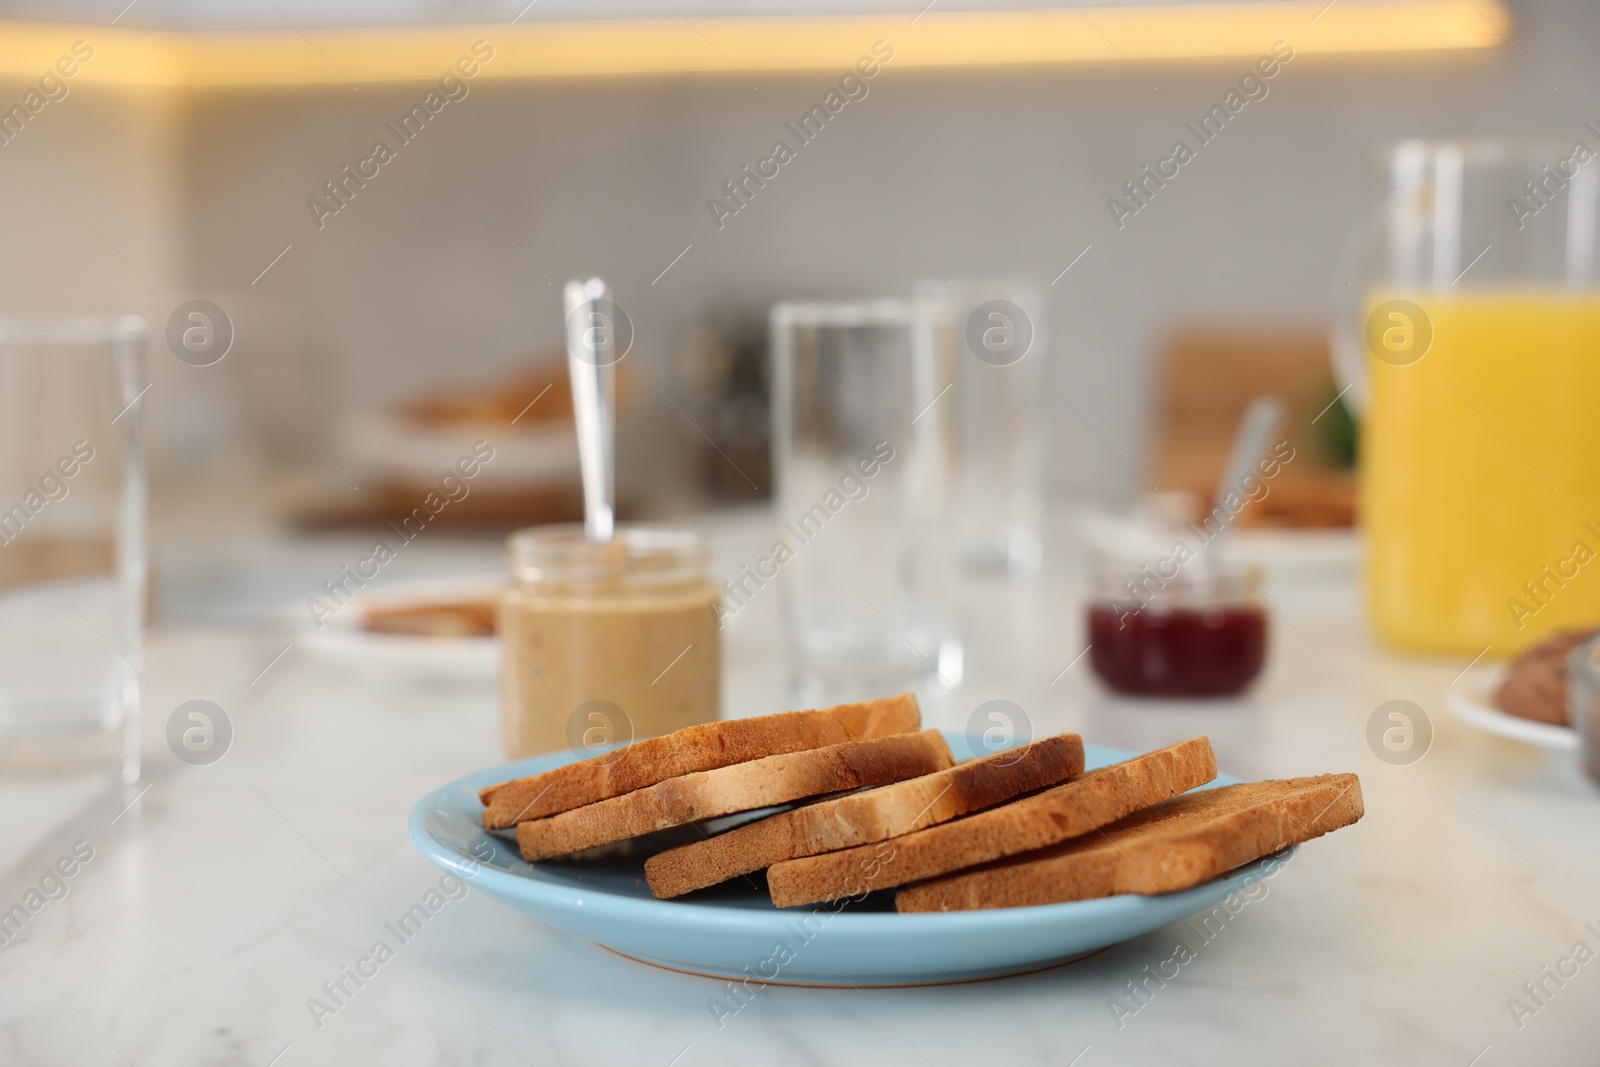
[478,693,922,830]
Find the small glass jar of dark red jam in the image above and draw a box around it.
[1088,557,1267,697]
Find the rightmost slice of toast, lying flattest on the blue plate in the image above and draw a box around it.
[894,774,1365,912]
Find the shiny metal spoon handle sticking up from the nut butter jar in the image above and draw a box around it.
[565,278,616,544]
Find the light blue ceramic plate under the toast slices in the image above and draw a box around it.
[410,734,1270,985]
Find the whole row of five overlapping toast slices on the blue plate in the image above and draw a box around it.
[480,693,1363,912]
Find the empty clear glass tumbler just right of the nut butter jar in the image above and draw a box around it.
[768,299,962,702]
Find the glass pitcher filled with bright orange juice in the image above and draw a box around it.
[1334,139,1600,656]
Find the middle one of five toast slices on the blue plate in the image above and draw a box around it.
[645,734,1083,899]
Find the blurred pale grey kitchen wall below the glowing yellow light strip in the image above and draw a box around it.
[0,0,1600,502]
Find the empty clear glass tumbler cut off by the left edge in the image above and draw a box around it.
[0,317,149,782]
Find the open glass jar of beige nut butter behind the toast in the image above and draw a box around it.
[501,525,722,758]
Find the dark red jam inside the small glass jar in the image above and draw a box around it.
[1090,603,1267,696]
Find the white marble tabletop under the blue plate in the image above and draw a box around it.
[0,518,1600,1067]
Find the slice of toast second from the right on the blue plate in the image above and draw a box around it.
[766,737,1216,907]
